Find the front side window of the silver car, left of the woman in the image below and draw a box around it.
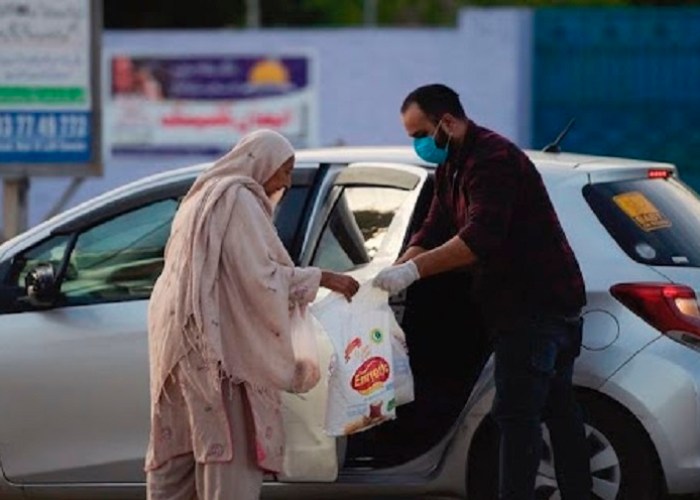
[16,199,178,305]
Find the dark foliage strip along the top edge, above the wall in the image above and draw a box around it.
[103,0,700,29]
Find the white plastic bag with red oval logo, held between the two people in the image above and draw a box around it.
[311,283,396,436]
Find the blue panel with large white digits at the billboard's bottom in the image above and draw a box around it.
[0,111,93,164]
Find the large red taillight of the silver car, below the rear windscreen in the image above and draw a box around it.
[610,283,700,346]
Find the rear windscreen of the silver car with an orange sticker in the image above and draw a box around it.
[583,178,700,266]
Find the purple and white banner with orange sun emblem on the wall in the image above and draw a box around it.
[104,54,316,157]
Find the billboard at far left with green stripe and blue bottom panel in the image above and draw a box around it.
[0,0,99,168]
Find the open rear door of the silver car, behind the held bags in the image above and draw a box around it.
[271,163,428,482]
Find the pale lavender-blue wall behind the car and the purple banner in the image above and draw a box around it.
[4,8,531,230]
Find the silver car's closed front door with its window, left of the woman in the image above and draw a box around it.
[0,196,178,483]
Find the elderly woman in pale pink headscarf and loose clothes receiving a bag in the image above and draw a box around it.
[145,130,359,500]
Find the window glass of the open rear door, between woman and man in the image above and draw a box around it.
[311,186,409,272]
